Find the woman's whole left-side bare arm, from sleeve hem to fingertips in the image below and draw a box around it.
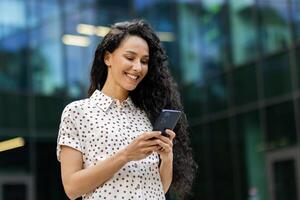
[60,131,160,199]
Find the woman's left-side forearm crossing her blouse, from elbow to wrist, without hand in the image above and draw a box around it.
[66,152,128,199]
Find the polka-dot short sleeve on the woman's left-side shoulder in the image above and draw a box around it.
[56,107,82,161]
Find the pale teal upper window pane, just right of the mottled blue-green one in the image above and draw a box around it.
[230,0,257,66]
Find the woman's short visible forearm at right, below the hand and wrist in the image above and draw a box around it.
[159,155,173,193]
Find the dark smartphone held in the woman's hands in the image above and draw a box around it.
[153,109,181,137]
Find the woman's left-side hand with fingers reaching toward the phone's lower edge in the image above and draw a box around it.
[121,131,161,162]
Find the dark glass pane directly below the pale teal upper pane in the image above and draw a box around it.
[233,65,257,105]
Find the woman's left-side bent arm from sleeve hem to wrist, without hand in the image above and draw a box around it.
[60,146,128,199]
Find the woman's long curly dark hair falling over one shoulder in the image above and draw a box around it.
[88,19,197,199]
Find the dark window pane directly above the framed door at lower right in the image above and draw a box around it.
[266,102,297,149]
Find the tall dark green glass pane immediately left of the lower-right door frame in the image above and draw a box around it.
[235,111,268,199]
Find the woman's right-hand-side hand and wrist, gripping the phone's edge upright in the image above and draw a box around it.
[157,129,176,161]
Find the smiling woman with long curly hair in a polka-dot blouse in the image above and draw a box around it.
[57,20,196,200]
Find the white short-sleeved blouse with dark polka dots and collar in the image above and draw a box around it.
[57,90,165,200]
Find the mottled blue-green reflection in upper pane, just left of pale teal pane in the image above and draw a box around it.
[199,0,230,76]
